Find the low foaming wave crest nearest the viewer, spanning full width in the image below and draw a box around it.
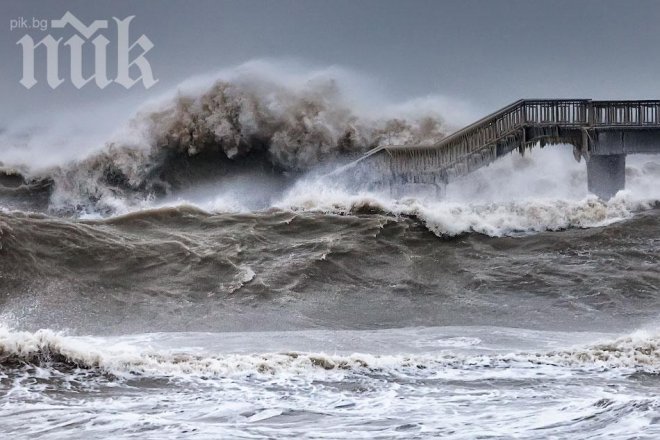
[0,329,660,378]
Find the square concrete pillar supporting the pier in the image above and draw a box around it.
[587,154,626,200]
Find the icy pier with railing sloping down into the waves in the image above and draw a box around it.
[350,99,660,199]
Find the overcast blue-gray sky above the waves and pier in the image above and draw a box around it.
[0,0,660,127]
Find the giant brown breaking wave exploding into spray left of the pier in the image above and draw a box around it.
[0,65,445,214]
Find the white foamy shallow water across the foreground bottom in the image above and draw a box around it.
[0,328,660,439]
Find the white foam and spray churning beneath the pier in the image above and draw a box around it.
[276,147,660,236]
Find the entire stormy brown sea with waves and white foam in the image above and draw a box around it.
[0,70,660,439]
